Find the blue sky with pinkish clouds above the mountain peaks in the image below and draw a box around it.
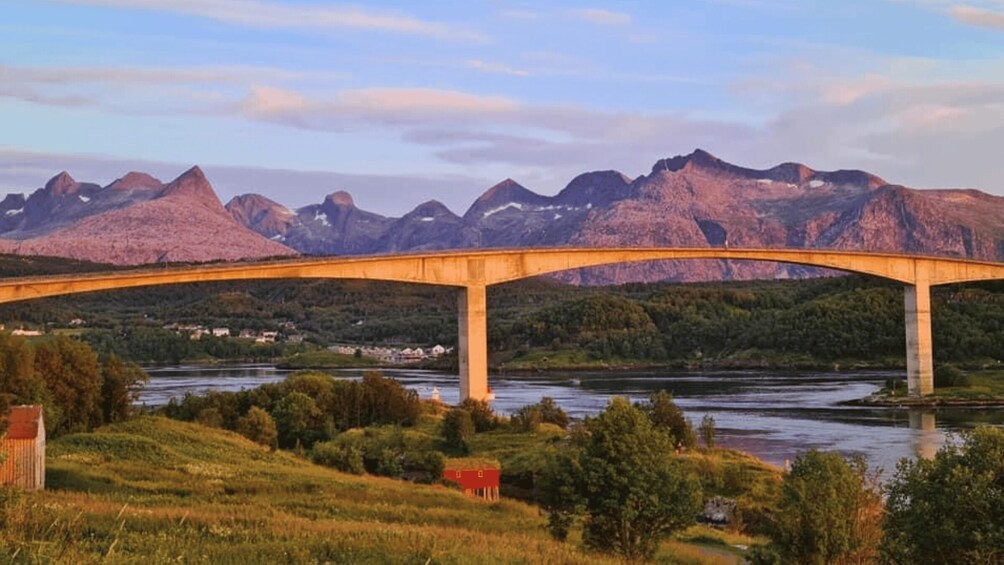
[0,0,1004,216]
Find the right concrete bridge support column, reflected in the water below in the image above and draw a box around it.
[904,277,935,396]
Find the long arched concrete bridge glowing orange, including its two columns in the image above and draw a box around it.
[0,248,1004,399]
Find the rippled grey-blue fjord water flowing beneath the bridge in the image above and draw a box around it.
[140,364,1004,477]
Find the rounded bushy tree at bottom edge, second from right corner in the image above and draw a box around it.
[771,450,883,564]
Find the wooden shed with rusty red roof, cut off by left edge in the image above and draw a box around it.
[0,405,45,490]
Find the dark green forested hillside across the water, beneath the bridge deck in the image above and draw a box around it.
[0,253,1004,369]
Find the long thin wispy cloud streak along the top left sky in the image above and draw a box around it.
[50,0,486,42]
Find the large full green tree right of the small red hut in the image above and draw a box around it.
[542,397,701,559]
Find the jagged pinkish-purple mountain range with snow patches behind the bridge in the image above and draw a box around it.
[0,150,1004,284]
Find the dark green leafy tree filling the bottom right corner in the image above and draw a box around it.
[882,427,1004,563]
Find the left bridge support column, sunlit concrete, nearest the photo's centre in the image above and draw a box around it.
[457,285,488,400]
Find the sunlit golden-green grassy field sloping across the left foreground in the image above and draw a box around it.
[0,416,767,563]
